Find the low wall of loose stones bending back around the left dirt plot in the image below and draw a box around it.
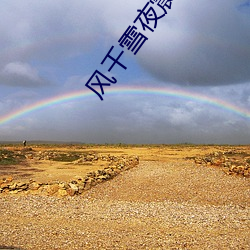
[0,150,139,196]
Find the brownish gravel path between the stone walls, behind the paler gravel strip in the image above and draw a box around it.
[87,160,250,207]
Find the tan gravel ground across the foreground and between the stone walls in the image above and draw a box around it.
[0,160,250,250]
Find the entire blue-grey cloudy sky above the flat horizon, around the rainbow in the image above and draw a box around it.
[0,0,250,144]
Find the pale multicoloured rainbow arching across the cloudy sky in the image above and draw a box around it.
[0,87,250,125]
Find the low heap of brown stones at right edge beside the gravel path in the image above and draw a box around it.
[194,151,250,177]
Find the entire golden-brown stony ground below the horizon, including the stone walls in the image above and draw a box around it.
[0,144,250,250]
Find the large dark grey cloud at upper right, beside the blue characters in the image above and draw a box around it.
[139,0,250,85]
